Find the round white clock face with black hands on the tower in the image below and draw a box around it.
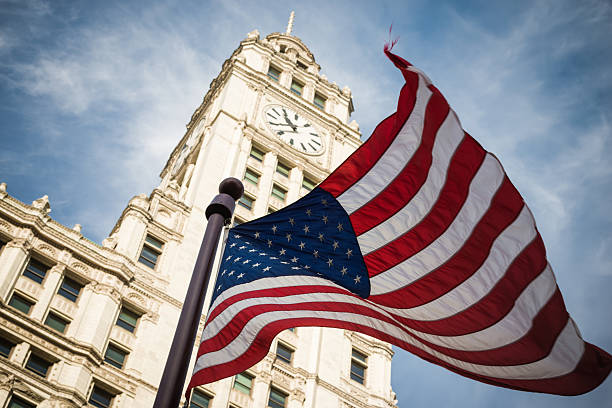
[265,105,323,154]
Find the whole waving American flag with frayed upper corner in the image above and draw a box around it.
[189,49,612,395]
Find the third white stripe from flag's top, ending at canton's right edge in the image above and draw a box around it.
[370,154,504,295]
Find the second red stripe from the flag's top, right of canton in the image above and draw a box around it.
[350,87,449,236]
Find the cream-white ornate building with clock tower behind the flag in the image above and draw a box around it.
[0,27,396,408]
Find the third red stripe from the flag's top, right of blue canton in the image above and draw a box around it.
[364,137,486,276]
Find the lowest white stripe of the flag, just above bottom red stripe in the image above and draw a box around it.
[194,310,584,380]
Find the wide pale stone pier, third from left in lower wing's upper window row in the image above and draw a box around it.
[72,281,121,354]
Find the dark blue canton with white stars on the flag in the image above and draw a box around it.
[213,187,370,301]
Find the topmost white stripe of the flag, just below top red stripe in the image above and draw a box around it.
[337,76,432,214]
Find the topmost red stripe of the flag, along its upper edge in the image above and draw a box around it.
[320,74,419,197]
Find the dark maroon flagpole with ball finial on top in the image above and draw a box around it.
[153,177,244,408]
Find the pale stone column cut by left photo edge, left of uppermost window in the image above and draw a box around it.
[0,229,33,302]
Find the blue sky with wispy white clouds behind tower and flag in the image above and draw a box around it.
[0,0,612,407]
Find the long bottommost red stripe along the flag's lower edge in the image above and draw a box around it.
[189,312,612,395]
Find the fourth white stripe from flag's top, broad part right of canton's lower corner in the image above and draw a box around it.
[380,205,537,321]
